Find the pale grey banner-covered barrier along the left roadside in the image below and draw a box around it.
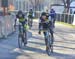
[0,15,14,38]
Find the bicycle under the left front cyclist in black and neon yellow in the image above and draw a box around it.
[18,23,27,48]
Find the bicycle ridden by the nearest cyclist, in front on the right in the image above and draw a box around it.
[45,29,53,56]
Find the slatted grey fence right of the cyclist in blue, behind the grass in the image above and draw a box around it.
[56,13,74,24]
